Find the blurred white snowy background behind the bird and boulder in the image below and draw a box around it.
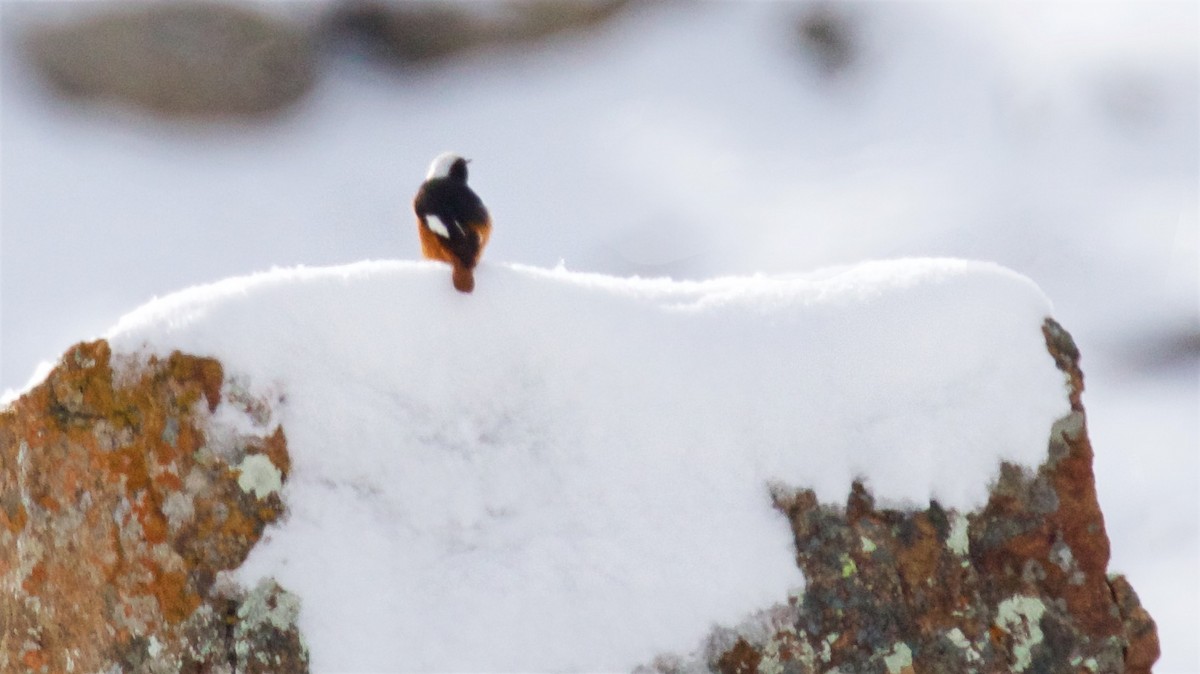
[0,0,1200,673]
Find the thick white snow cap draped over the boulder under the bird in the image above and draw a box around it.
[107,259,1069,673]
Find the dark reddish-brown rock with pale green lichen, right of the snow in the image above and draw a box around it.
[647,320,1159,674]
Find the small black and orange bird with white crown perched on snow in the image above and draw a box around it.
[413,152,492,293]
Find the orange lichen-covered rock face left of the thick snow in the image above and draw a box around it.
[0,341,307,674]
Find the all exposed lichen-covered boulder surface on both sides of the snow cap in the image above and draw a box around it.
[0,320,1158,674]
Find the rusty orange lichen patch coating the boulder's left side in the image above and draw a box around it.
[0,341,289,672]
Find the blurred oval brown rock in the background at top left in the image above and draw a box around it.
[26,1,314,116]
